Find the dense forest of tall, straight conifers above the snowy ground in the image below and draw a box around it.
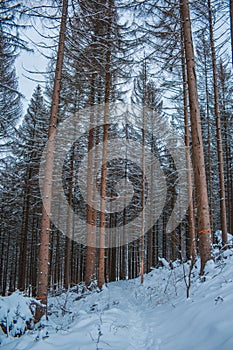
[0,0,233,350]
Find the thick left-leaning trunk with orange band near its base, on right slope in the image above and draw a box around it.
[180,0,212,275]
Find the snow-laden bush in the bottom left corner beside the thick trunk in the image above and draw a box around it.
[0,292,33,343]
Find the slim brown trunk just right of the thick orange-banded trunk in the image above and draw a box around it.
[208,0,227,246]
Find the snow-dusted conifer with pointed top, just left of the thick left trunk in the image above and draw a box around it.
[13,85,49,291]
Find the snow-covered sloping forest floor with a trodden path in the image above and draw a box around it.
[0,250,233,350]
